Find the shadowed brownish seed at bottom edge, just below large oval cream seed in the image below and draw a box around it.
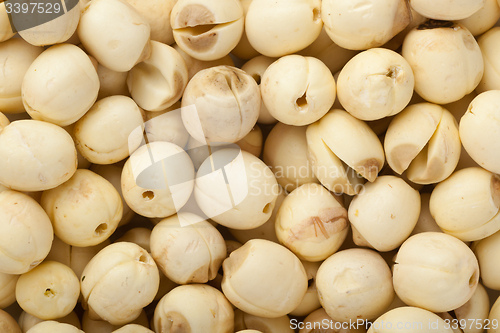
[234,309,293,333]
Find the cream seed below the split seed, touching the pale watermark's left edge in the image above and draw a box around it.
[74,96,144,164]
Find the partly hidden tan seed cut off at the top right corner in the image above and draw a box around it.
[457,0,500,35]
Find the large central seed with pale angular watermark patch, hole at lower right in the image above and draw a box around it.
[194,149,279,229]
